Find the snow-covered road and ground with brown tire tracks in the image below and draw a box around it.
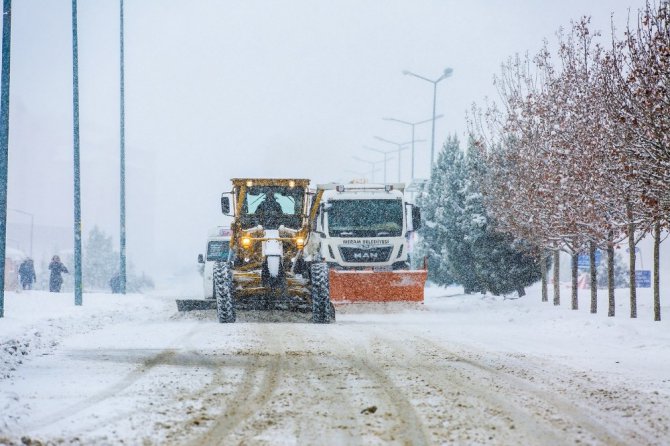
[0,287,670,445]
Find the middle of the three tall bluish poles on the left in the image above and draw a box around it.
[72,0,83,305]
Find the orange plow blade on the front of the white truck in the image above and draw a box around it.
[330,269,428,303]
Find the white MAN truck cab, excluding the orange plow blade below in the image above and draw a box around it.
[306,183,418,271]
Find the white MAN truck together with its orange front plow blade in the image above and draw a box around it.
[305,183,427,302]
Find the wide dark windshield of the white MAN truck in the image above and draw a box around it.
[326,200,403,237]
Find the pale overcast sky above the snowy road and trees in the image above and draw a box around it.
[0,0,644,277]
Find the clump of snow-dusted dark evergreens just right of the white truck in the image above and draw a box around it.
[420,137,540,295]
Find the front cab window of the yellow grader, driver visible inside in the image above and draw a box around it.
[241,186,305,229]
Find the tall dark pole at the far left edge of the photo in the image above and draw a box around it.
[0,0,12,317]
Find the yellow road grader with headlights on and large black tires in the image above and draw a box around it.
[213,178,335,323]
